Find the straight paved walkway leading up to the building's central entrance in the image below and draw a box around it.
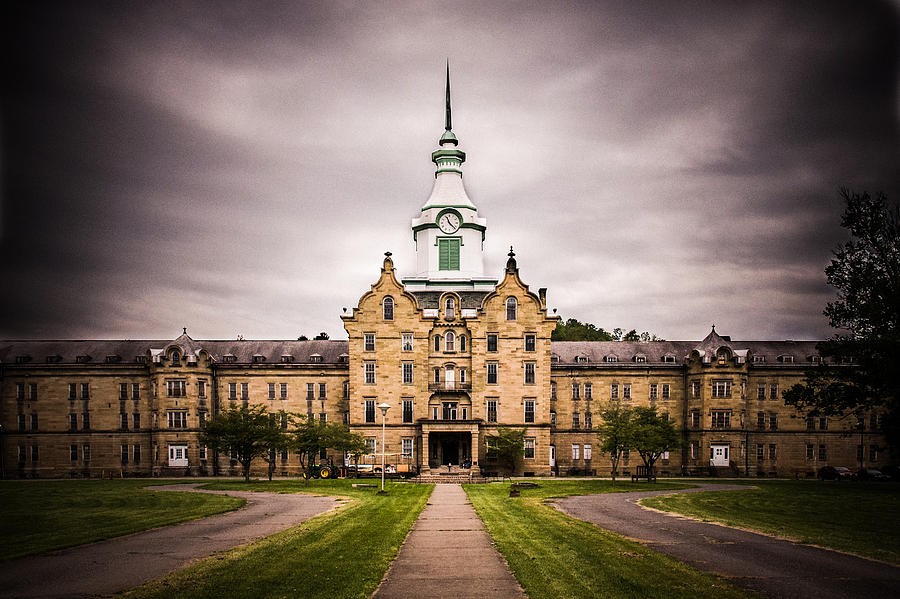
[373,484,525,599]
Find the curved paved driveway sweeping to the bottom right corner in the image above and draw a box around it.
[554,484,900,599]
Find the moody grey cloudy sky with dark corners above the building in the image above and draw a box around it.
[0,1,900,339]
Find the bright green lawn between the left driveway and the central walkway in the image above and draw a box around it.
[127,480,432,599]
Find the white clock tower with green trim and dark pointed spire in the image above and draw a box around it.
[403,64,497,291]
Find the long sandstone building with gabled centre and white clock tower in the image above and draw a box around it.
[0,74,884,477]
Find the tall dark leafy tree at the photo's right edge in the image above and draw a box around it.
[784,189,900,449]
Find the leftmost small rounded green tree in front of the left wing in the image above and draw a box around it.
[199,406,283,482]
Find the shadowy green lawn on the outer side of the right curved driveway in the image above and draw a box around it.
[641,480,900,564]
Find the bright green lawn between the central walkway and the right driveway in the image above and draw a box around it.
[464,480,756,599]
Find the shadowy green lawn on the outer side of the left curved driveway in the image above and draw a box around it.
[0,480,244,560]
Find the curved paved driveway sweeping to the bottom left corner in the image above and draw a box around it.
[0,483,340,598]
